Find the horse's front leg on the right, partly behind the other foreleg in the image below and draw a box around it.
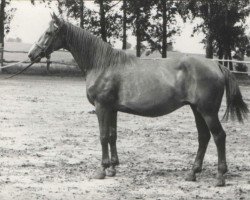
[107,111,119,177]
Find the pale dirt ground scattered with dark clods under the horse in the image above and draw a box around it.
[0,75,250,200]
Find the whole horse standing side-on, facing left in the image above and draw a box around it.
[29,15,248,186]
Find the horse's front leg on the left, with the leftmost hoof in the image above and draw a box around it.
[95,103,111,179]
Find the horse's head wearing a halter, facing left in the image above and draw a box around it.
[28,13,64,62]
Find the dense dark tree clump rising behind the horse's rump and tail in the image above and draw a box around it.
[182,0,250,63]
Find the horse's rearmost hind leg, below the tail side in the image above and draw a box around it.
[203,114,227,186]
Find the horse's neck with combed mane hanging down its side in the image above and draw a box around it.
[64,22,137,69]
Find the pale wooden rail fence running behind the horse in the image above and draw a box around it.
[0,43,250,76]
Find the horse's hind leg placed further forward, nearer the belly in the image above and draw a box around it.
[186,106,211,181]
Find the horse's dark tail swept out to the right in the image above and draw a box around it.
[220,65,249,123]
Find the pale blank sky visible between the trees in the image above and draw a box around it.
[7,0,205,54]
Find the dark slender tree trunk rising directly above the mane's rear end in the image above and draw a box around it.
[135,1,141,57]
